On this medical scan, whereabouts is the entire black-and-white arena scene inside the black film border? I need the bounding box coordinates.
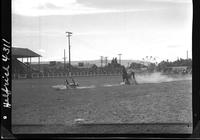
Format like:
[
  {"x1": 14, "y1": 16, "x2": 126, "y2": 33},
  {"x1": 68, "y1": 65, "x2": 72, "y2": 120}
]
[{"x1": 11, "y1": 0, "x2": 193, "y2": 134}]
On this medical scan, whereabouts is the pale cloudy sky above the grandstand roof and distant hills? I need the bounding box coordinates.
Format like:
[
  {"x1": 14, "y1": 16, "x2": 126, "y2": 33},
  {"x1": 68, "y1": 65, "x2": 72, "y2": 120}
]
[{"x1": 12, "y1": 0, "x2": 192, "y2": 61}]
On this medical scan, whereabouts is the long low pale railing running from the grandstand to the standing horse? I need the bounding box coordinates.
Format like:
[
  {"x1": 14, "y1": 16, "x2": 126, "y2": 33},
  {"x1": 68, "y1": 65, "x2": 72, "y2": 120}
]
[{"x1": 12, "y1": 72, "x2": 121, "y2": 79}]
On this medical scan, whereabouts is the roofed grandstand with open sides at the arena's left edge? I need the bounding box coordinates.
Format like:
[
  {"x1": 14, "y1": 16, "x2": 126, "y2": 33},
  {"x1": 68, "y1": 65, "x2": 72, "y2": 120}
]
[{"x1": 12, "y1": 47, "x2": 41, "y2": 78}]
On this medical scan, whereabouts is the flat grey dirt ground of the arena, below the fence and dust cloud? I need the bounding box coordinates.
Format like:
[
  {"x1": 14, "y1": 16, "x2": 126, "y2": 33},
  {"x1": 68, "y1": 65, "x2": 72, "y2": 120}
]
[{"x1": 12, "y1": 76, "x2": 192, "y2": 134}]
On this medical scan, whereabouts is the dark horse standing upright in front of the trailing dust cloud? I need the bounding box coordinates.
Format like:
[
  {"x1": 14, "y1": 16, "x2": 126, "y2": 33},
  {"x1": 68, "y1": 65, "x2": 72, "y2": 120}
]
[{"x1": 122, "y1": 67, "x2": 138, "y2": 85}]
